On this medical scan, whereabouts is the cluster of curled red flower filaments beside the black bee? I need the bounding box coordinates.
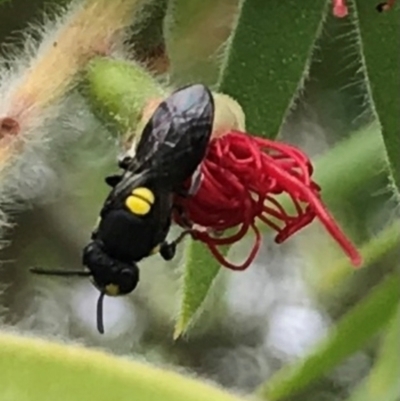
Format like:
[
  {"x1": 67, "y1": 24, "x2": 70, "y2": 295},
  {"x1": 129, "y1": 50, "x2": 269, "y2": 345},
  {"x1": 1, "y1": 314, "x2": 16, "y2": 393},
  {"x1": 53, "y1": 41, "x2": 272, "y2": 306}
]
[{"x1": 175, "y1": 131, "x2": 361, "y2": 270}]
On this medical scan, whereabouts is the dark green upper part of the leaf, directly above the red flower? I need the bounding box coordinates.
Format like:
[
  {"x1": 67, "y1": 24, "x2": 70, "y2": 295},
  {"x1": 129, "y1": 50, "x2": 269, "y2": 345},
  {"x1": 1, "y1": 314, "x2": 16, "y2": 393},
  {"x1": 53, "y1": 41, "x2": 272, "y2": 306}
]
[{"x1": 218, "y1": 0, "x2": 330, "y2": 138}]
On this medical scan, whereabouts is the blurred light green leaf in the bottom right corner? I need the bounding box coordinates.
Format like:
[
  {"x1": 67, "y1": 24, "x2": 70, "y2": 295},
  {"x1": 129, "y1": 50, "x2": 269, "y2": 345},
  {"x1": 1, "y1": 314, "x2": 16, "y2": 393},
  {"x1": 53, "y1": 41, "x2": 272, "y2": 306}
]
[{"x1": 348, "y1": 305, "x2": 400, "y2": 401}]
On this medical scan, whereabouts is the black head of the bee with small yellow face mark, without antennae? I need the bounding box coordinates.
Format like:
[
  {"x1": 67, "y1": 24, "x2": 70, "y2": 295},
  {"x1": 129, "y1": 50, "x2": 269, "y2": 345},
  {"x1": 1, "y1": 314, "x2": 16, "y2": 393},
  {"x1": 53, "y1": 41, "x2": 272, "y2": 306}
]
[{"x1": 82, "y1": 240, "x2": 139, "y2": 296}]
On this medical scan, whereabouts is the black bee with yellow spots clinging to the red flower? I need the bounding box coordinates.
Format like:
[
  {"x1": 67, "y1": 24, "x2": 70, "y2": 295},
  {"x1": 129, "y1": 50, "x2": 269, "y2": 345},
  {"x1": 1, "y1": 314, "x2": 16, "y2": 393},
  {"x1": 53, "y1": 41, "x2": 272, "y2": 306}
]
[{"x1": 31, "y1": 84, "x2": 214, "y2": 333}]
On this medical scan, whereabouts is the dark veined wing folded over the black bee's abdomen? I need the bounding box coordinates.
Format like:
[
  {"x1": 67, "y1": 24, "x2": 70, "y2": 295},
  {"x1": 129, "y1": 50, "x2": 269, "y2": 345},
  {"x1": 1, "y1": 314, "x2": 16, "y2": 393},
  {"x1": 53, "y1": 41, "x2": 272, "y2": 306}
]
[{"x1": 128, "y1": 84, "x2": 214, "y2": 188}]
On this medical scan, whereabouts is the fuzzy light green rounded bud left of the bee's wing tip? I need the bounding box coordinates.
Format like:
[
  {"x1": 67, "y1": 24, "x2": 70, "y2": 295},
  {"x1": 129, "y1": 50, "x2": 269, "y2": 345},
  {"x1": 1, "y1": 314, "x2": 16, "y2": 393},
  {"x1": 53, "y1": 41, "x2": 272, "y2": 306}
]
[{"x1": 84, "y1": 57, "x2": 164, "y2": 132}]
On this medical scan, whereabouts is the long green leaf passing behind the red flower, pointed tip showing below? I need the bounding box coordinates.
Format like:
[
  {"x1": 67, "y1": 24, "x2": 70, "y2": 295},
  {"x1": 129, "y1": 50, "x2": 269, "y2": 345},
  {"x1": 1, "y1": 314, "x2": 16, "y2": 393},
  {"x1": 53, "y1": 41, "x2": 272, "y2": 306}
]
[{"x1": 175, "y1": 0, "x2": 327, "y2": 337}]
